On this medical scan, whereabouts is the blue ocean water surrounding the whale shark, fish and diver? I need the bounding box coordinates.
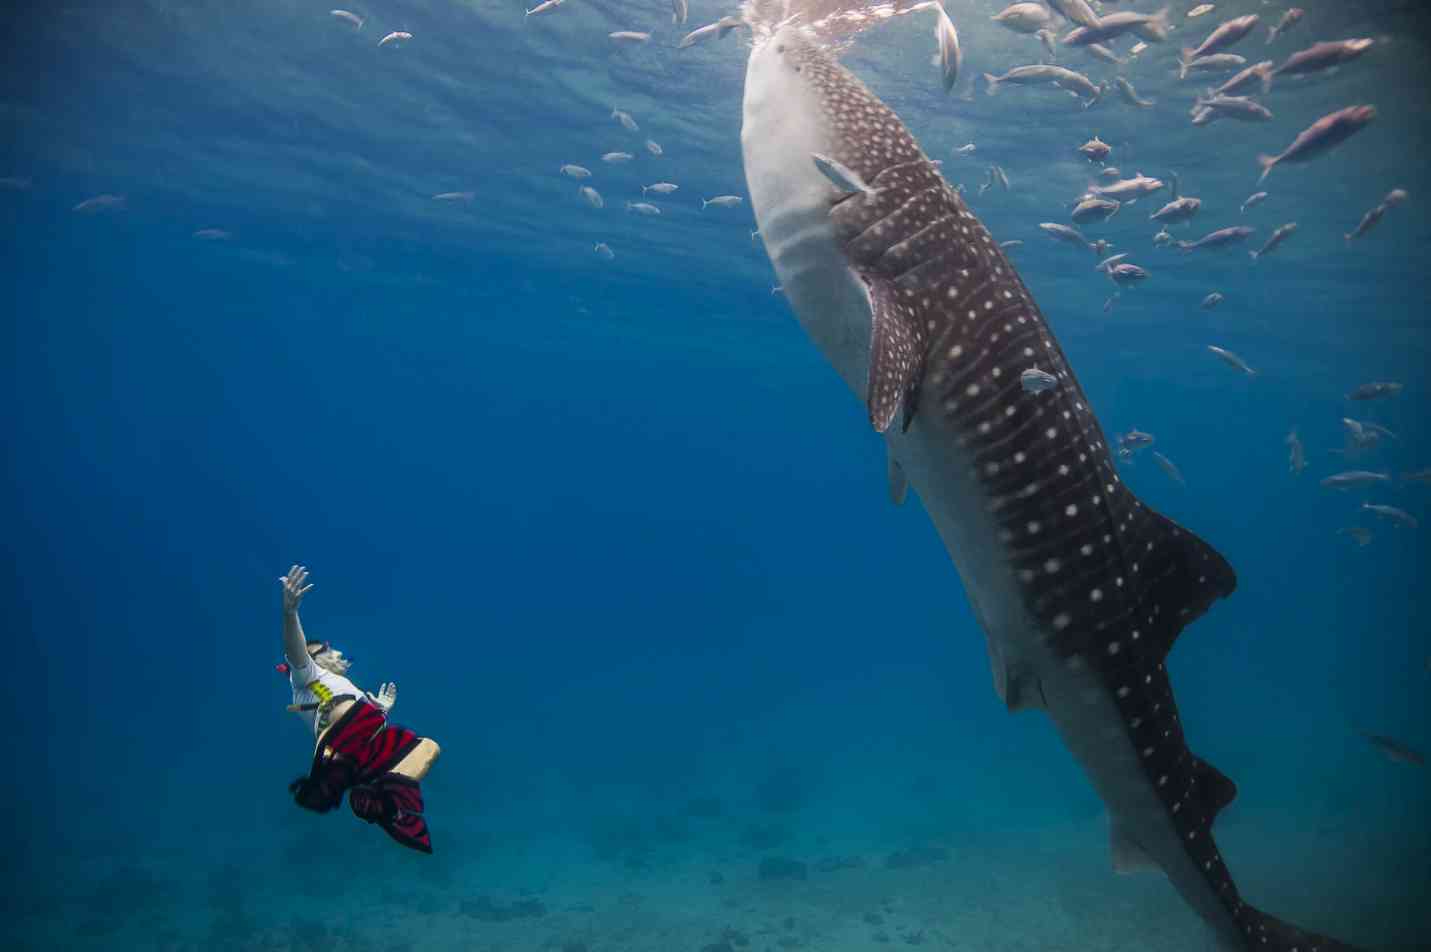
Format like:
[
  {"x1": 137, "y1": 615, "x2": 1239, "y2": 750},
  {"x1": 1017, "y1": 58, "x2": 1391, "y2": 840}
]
[{"x1": 0, "y1": 0, "x2": 1431, "y2": 952}]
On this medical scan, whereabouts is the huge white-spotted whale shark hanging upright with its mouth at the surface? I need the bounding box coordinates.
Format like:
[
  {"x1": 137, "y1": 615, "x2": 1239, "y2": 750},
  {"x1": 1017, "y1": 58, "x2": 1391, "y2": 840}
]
[{"x1": 741, "y1": 9, "x2": 1351, "y2": 952}]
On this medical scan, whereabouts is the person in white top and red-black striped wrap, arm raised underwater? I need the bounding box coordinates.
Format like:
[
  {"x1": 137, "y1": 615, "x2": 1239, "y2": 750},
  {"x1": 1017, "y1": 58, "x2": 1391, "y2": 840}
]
[{"x1": 278, "y1": 565, "x2": 441, "y2": 853}]
